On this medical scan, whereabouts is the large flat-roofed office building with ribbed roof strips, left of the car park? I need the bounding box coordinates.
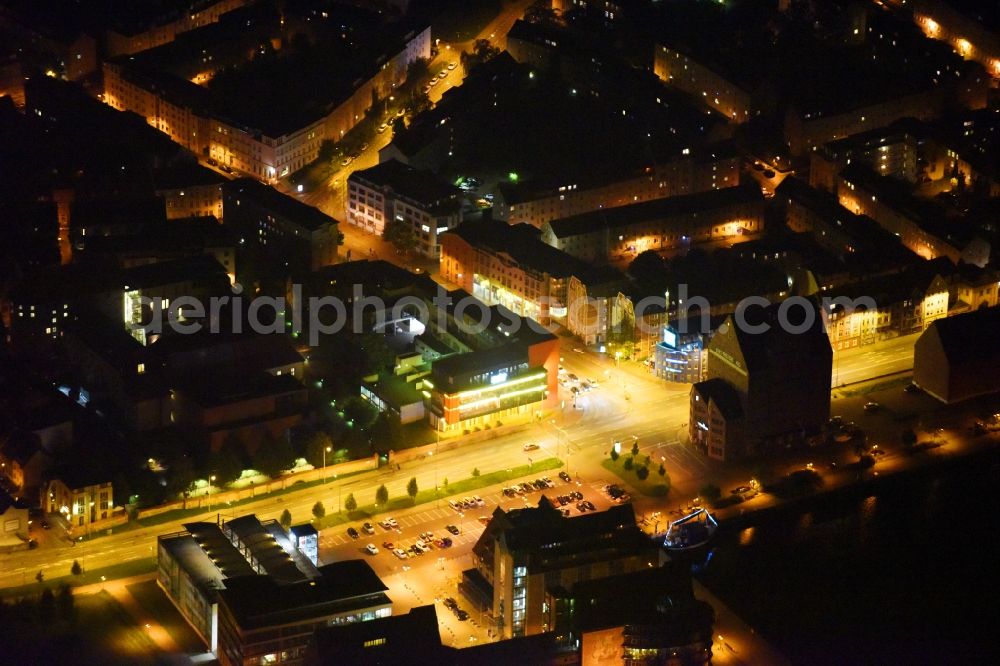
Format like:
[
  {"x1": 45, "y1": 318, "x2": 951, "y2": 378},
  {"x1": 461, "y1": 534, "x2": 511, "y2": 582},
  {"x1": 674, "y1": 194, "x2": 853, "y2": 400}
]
[{"x1": 157, "y1": 508, "x2": 392, "y2": 666}]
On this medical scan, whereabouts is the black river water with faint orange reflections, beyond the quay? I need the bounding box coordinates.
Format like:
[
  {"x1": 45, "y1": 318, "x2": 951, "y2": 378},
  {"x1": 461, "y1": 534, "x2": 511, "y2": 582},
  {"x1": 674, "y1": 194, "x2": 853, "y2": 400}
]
[{"x1": 698, "y1": 451, "x2": 1000, "y2": 666}]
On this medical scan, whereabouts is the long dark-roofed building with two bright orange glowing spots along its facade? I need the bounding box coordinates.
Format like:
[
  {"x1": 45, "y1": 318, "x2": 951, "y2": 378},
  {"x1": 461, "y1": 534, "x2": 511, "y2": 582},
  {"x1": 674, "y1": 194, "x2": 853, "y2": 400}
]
[{"x1": 542, "y1": 186, "x2": 764, "y2": 262}]
